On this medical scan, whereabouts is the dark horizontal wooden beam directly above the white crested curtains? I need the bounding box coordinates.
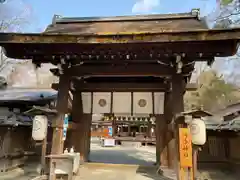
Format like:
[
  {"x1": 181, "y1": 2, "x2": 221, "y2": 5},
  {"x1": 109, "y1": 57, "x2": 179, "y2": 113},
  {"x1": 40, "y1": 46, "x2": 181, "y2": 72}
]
[{"x1": 52, "y1": 82, "x2": 197, "y2": 92}]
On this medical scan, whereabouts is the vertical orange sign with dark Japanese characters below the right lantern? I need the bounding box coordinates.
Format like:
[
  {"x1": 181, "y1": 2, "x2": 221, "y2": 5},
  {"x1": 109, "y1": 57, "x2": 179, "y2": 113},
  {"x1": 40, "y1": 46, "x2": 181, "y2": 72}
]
[{"x1": 179, "y1": 128, "x2": 193, "y2": 167}]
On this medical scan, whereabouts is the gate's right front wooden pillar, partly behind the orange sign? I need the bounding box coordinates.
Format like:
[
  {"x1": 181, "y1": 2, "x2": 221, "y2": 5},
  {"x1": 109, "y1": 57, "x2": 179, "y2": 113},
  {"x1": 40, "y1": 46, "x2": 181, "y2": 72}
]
[{"x1": 172, "y1": 74, "x2": 185, "y2": 180}]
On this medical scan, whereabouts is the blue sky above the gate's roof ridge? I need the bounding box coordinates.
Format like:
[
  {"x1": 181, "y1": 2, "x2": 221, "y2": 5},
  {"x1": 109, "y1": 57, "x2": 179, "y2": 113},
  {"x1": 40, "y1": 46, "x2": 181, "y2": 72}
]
[{"x1": 14, "y1": 0, "x2": 216, "y2": 32}]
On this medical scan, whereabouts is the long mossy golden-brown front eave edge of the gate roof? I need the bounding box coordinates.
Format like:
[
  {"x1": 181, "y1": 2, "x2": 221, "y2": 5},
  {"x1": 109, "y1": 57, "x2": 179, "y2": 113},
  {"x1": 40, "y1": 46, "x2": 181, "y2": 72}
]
[{"x1": 0, "y1": 28, "x2": 240, "y2": 45}]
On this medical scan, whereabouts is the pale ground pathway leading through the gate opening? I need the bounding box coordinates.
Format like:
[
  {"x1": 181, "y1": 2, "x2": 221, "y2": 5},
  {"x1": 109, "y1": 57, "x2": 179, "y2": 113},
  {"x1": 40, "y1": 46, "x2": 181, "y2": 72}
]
[{"x1": 76, "y1": 138, "x2": 176, "y2": 180}]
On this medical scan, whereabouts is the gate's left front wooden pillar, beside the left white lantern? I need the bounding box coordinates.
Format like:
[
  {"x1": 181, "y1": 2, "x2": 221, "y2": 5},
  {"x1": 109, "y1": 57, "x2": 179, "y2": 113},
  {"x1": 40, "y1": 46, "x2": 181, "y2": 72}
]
[{"x1": 51, "y1": 75, "x2": 70, "y2": 154}]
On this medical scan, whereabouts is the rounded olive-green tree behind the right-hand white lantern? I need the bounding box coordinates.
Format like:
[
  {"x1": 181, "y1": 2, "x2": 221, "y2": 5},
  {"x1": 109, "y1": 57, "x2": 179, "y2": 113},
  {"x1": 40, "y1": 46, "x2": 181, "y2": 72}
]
[{"x1": 185, "y1": 70, "x2": 240, "y2": 111}]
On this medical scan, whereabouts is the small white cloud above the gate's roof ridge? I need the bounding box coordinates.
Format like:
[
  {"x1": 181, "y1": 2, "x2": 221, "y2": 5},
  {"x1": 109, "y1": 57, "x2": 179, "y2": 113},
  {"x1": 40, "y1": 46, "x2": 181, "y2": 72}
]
[{"x1": 132, "y1": 0, "x2": 159, "y2": 13}]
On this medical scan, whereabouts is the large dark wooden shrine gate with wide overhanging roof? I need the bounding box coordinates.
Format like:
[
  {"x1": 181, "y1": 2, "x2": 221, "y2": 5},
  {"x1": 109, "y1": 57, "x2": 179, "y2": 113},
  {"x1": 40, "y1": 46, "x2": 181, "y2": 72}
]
[{"x1": 0, "y1": 10, "x2": 240, "y2": 180}]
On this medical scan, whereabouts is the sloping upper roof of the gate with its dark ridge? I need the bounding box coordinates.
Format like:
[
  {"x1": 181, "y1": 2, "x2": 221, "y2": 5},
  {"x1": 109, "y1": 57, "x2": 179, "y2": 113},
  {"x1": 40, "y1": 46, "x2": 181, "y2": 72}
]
[{"x1": 44, "y1": 11, "x2": 207, "y2": 35}]
